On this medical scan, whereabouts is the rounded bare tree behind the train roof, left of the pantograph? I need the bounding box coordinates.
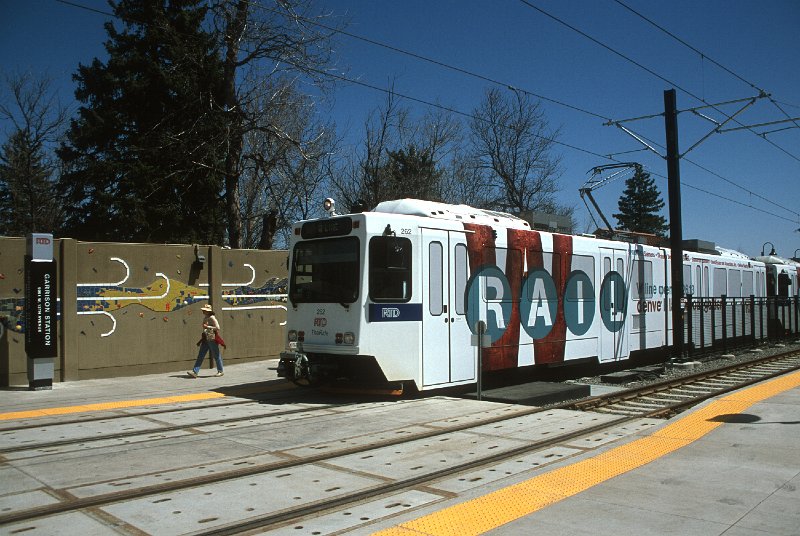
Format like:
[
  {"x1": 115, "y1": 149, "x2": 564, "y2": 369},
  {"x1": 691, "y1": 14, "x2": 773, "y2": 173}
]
[{"x1": 470, "y1": 88, "x2": 561, "y2": 213}]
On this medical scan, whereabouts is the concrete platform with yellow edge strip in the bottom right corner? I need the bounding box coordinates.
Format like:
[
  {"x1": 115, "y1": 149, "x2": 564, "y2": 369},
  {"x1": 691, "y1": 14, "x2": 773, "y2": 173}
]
[{"x1": 374, "y1": 372, "x2": 800, "y2": 536}]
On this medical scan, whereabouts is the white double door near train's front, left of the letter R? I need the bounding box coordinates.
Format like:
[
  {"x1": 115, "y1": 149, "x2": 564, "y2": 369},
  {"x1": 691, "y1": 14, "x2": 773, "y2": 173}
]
[{"x1": 422, "y1": 229, "x2": 475, "y2": 387}]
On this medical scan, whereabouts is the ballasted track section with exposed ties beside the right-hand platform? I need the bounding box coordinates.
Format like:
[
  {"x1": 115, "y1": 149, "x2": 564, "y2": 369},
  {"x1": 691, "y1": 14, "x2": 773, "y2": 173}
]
[{"x1": 557, "y1": 350, "x2": 800, "y2": 418}]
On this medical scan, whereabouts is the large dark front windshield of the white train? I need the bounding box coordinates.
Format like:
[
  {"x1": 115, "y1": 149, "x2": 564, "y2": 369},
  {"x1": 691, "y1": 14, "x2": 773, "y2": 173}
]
[{"x1": 289, "y1": 237, "x2": 360, "y2": 304}]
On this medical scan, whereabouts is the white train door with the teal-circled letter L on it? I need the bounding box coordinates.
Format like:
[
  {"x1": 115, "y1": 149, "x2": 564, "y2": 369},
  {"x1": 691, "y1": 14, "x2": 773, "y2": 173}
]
[{"x1": 599, "y1": 248, "x2": 630, "y2": 361}]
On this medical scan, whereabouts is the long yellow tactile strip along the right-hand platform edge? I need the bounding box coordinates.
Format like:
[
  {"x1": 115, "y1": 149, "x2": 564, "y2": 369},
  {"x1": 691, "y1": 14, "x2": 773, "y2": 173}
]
[{"x1": 373, "y1": 372, "x2": 800, "y2": 536}]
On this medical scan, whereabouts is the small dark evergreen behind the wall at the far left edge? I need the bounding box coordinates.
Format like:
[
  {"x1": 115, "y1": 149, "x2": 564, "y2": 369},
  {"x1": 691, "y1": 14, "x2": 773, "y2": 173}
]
[{"x1": 0, "y1": 130, "x2": 59, "y2": 236}]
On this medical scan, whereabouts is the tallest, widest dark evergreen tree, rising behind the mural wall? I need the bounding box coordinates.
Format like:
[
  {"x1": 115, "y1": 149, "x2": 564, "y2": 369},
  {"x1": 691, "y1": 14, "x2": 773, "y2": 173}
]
[{"x1": 59, "y1": 0, "x2": 225, "y2": 244}]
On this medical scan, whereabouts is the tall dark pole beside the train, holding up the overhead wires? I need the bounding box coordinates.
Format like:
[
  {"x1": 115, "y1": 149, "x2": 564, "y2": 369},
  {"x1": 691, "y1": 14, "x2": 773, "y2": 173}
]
[{"x1": 664, "y1": 89, "x2": 684, "y2": 358}]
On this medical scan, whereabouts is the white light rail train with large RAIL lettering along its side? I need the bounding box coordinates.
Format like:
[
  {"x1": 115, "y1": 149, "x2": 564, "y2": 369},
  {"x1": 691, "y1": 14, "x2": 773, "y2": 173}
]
[{"x1": 279, "y1": 199, "x2": 767, "y2": 390}]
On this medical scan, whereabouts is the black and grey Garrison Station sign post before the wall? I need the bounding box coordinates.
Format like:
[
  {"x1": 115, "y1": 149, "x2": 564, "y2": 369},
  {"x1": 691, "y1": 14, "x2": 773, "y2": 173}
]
[{"x1": 25, "y1": 233, "x2": 58, "y2": 391}]
